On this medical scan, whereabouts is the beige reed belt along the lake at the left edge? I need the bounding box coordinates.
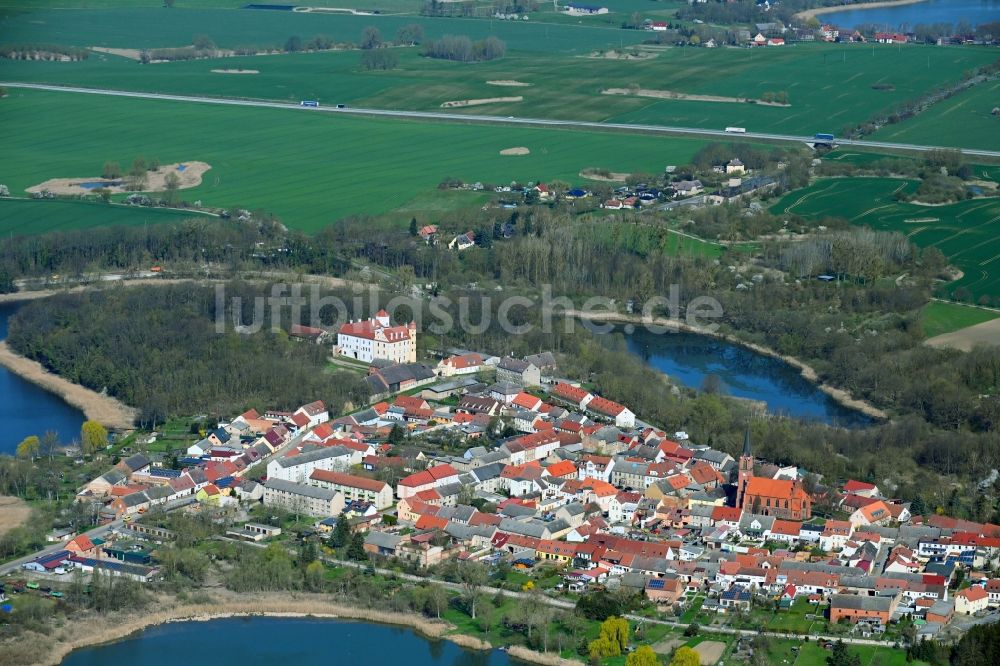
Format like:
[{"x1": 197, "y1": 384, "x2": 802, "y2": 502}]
[{"x1": 0, "y1": 340, "x2": 138, "y2": 431}]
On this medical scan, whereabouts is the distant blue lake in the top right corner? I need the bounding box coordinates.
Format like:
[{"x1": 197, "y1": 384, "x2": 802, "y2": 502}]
[{"x1": 817, "y1": 0, "x2": 1000, "y2": 30}]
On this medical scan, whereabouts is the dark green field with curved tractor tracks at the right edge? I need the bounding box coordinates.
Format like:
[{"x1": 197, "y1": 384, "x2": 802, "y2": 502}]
[{"x1": 771, "y1": 178, "x2": 1000, "y2": 302}]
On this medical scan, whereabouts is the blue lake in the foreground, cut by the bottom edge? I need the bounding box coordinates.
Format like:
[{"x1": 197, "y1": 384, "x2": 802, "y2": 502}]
[{"x1": 63, "y1": 617, "x2": 525, "y2": 666}]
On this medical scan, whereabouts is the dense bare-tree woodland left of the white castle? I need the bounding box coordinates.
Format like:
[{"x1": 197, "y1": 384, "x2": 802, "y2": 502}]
[{"x1": 8, "y1": 283, "x2": 366, "y2": 428}]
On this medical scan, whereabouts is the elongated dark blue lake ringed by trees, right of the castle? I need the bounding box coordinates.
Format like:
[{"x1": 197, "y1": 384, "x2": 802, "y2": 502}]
[{"x1": 625, "y1": 327, "x2": 872, "y2": 428}]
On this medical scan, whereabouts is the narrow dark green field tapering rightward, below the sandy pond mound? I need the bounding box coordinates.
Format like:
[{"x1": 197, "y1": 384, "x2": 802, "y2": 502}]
[{"x1": 0, "y1": 199, "x2": 211, "y2": 238}]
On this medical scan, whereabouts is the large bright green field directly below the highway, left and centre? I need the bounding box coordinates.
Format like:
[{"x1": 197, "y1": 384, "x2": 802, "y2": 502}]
[{"x1": 0, "y1": 91, "x2": 704, "y2": 231}]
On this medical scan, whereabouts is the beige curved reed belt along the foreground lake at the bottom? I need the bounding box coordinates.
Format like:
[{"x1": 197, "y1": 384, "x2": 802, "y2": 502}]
[{"x1": 47, "y1": 595, "x2": 560, "y2": 666}]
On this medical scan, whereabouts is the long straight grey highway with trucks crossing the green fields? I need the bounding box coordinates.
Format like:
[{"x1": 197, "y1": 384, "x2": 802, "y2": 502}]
[{"x1": 0, "y1": 82, "x2": 1000, "y2": 158}]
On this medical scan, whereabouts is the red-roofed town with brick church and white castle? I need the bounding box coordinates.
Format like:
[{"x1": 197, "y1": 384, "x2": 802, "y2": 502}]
[{"x1": 7, "y1": 311, "x2": 1000, "y2": 642}]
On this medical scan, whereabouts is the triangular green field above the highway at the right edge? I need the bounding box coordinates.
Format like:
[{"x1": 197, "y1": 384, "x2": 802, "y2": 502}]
[{"x1": 872, "y1": 81, "x2": 1000, "y2": 150}]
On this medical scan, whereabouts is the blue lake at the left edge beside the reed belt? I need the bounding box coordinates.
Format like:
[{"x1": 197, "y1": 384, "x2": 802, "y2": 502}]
[{"x1": 0, "y1": 303, "x2": 85, "y2": 455}]
